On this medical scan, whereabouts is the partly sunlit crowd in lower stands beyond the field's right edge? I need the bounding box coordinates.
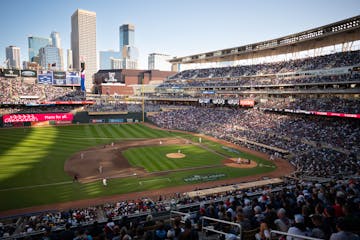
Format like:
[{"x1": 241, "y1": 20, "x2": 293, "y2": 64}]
[{"x1": 150, "y1": 107, "x2": 360, "y2": 176}]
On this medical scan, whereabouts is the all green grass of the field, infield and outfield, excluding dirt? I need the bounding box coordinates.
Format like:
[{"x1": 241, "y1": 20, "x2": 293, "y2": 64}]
[{"x1": 0, "y1": 124, "x2": 274, "y2": 211}]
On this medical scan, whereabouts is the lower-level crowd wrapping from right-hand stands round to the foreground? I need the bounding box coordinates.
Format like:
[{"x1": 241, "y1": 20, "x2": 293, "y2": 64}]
[{"x1": 0, "y1": 107, "x2": 360, "y2": 239}]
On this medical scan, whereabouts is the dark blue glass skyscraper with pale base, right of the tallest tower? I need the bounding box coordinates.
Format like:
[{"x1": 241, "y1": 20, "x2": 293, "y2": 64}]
[{"x1": 120, "y1": 24, "x2": 139, "y2": 69}]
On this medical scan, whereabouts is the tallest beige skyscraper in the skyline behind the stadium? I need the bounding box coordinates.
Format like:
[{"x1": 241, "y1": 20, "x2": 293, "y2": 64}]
[{"x1": 71, "y1": 9, "x2": 97, "y2": 91}]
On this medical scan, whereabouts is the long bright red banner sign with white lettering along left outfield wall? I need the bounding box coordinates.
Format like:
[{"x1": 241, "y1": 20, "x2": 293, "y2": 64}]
[{"x1": 3, "y1": 113, "x2": 74, "y2": 123}]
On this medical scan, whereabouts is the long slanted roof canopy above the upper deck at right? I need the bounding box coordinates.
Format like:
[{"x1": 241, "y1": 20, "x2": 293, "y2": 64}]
[{"x1": 170, "y1": 15, "x2": 360, "y2": 64}]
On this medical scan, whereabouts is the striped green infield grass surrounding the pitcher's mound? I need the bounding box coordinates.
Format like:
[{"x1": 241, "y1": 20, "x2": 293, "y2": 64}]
[{"x1": 122, "y1": 145, "x2": 224, "y2": 172}]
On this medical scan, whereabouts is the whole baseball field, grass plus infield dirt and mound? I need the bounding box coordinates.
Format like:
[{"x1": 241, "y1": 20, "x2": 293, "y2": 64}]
[{"x1": 0, "y1": 124, "x2": 276, "y2": 212}]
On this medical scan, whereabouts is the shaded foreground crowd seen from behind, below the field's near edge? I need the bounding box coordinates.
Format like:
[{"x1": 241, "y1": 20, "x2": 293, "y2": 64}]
[{"x1": 0, "y1": 176, "x2": 360, "y2": 240}]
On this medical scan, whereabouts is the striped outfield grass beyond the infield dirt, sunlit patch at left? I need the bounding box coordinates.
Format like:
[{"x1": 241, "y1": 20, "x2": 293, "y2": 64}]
[{"x1": 0, "y1": 124, "x2": 169, "y2": 189}]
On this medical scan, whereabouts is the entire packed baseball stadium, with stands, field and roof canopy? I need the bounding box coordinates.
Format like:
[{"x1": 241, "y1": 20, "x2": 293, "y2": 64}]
[{"x1": 0, "y1": 16, "x2": 360, "y2": 239}]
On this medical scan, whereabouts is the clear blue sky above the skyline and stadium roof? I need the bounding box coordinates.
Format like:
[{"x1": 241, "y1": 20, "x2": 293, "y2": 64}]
[{"x1": 0, "y1": 0, "x2": 360, "y2": 68}]
